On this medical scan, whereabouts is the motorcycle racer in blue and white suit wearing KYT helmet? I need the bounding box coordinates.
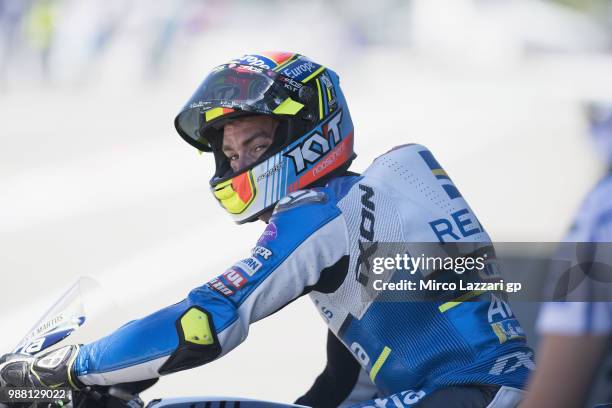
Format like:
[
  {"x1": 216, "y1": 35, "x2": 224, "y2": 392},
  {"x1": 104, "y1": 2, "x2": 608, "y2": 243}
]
[{"x1": 0, "y1": 52, "x2": 534, "y2": 408}]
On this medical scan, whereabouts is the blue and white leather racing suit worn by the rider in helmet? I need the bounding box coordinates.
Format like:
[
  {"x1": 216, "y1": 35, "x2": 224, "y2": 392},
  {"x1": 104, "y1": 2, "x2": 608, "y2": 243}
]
[{"x1": 74, "y1": 145, "x2": 534, "y2": 406}]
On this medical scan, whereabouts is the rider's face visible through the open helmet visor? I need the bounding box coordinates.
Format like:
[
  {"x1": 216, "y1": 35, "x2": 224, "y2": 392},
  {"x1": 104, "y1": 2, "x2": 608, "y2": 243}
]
[{"x1": 221, "y1": 116, "x2": 278, "y2": 172}]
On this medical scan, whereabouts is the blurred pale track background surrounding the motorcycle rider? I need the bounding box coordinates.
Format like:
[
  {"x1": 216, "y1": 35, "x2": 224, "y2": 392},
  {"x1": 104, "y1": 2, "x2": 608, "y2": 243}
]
[{"x1": 0, "y1": 0, "x2": 612, "y2": 401}]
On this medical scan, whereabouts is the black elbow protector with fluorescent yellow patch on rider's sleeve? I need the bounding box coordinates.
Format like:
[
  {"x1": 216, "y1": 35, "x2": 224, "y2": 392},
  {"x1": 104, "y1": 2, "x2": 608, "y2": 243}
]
[{"x1": 158, "y1": 306, "x2": 221, "y2": 375}]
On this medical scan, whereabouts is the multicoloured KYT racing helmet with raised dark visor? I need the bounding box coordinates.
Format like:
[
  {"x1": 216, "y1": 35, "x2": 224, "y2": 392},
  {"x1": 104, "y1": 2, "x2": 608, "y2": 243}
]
[{"x1": 174, "y1": 52, "x2": 356, "y2": 224}]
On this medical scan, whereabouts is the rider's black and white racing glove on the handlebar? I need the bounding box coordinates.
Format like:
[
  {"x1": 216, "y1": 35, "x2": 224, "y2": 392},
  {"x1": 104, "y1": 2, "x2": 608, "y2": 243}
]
[{"x1": 0, "y1": 345, "x2": 84, "y2": 390}]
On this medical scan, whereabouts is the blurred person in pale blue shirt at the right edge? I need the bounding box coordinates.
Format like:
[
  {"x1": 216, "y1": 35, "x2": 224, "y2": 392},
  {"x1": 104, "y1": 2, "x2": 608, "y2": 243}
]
[{"x1": 521, "y1": 103, "x2": 612, "y2": 408}]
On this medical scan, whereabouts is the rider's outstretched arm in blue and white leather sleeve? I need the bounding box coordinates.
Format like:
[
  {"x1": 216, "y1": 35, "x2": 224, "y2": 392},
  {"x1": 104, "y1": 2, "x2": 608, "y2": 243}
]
[{"x1": 74, "y1": 190, "x2": 348, "y2": 385}]
